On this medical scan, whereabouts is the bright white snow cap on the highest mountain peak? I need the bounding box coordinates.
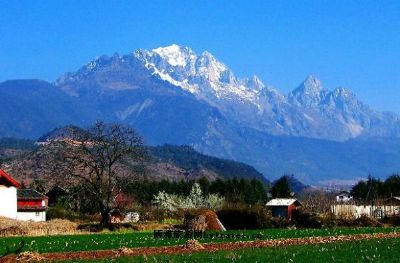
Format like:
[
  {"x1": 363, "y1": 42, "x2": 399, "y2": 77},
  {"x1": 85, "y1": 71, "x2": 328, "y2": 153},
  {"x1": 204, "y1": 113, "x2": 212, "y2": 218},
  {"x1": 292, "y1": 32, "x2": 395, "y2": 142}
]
[{"x1": 134, "y1": 44, "x2": 264, "y2": 102}]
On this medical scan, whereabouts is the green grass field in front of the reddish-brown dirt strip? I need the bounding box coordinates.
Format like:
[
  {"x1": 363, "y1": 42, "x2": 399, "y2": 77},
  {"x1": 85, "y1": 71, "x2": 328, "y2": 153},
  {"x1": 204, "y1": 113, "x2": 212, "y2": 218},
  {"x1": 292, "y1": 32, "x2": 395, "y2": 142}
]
[{"x1": 72, "y1": 239, "x2": 400, "y2": 263}]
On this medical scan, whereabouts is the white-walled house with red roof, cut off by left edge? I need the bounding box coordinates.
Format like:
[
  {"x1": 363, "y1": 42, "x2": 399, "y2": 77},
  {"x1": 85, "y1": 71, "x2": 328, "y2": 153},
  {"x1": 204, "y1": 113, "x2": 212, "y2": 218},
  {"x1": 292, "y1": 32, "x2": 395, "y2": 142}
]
[{"x1": 0, "y1": 169, "x2": 20, "y2": 219}]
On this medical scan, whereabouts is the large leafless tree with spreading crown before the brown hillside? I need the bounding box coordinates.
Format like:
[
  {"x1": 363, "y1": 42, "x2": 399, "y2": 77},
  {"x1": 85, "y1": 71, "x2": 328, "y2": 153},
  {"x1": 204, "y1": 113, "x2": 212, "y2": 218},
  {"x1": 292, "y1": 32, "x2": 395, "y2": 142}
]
[{"x1": 42, "y1": 122, "x2": 147, "y2": 227}]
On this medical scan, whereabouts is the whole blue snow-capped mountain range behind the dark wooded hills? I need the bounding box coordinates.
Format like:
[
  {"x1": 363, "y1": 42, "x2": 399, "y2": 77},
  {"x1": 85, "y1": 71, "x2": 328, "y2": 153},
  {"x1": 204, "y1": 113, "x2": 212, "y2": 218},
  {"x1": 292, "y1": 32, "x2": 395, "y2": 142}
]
[{"x1": 0, "y1": 45, "x2": 400, "y2": 184}]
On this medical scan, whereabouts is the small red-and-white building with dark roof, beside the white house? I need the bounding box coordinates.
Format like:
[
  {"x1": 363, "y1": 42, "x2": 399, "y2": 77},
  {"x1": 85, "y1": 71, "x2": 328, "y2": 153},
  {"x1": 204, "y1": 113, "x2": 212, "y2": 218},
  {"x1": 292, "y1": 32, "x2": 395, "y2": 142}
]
[{"x1": 17, "y1": 189, "x2": 48, "y2": 222}]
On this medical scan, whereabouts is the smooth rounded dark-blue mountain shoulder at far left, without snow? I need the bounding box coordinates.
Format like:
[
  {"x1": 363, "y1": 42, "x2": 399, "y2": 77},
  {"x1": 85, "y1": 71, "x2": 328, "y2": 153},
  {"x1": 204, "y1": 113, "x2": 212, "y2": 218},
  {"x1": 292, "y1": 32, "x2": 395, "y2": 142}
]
[{"x1": 0, "y1": 80, "x2": 86, "y2": 138}]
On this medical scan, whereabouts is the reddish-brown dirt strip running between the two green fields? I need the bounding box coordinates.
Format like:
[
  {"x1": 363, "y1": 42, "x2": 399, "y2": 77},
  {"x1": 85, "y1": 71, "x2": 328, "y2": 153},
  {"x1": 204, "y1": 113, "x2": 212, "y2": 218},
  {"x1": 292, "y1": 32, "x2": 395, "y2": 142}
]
[{"x1": 0, "y1": 233, "x2": 400, "y2": 262}]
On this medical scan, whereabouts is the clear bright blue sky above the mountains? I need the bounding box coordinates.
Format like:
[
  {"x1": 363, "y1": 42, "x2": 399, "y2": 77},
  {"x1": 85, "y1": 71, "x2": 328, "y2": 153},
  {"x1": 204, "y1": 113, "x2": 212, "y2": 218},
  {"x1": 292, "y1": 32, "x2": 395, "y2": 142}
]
[{"x1": 0, "y1": 0, "x2": 400, "y2": 112}]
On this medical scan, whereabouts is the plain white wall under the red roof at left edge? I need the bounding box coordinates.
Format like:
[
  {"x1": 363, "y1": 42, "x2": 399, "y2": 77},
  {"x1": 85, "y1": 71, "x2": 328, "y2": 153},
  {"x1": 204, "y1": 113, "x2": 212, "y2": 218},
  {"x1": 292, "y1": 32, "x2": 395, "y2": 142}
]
[{"x1": 0, "y1": 185, "x2": 17, "y2": 219}]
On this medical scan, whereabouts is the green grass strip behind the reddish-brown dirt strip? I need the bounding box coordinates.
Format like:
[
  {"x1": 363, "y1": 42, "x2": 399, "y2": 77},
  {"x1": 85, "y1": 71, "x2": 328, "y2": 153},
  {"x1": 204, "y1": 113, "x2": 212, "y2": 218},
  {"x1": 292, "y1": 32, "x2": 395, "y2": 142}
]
[{"x1": 0, "y1": 228, "x2": 400, "y2": 255}]
